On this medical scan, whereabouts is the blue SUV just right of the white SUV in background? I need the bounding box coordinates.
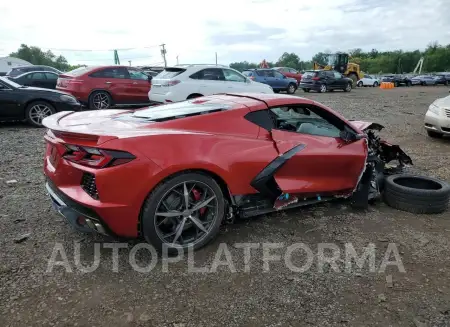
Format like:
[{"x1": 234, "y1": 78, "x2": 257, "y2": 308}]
[{"x1": 242, "y1": 69, "x2": 298, "y2": 94}]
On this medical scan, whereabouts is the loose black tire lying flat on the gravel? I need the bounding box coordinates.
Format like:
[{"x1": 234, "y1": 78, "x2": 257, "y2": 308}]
[{"x1": 383, "y1": 174, "x2": 450, "y2": 214}]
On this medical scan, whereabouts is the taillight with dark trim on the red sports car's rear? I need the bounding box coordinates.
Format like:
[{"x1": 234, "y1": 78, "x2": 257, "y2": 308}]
[{"x1": 63, "y1": 144, "x2": 136, "y2": 168}]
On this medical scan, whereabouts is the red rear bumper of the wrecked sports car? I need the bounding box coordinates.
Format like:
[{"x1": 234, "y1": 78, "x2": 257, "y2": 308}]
[{"x1": 44, "y1": 140, "x2": 160, "y2": 238}]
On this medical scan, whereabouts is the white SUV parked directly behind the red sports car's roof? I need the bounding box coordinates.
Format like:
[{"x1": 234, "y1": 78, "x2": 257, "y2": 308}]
[{"x1": 148, "y1": 65, "x2": 273, "y2": 103}]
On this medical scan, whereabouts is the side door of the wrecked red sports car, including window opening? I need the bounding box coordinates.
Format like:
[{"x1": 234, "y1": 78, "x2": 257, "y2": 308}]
[{"x1": 270, "y1": 105, "x2": 367, "y2": 196}]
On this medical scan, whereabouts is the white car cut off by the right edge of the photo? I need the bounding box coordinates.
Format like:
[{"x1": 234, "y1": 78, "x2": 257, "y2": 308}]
[{"x1": 424, "y1": 91, "x2": 450, "y2": 138}]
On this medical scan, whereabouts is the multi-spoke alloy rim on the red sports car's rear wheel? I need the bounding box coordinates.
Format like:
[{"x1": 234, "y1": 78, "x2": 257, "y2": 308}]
[{"x1": 154, "y1": 181, "x2": 219, "y2": 248}]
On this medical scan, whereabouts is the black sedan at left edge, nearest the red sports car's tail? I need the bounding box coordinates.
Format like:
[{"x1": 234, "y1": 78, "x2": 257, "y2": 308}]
[{"x1": 0, "y1": 77, "x2": 81, "y2": 127}]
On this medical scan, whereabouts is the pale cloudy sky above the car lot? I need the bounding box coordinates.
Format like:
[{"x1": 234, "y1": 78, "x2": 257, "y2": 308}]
[{"x1": 0, "y1": 0, "x2": 450, "y2": 65}]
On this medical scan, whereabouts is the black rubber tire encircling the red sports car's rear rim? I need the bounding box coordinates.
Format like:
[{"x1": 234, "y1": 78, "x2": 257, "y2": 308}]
[{"x1": 141, "y1": 172, "x2": 226, "y2": 254}]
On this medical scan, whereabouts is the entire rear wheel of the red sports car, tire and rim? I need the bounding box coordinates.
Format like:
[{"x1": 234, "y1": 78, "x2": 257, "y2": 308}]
[{"x1": 141, "y1": 173, "x2": 225, "y2": 253}]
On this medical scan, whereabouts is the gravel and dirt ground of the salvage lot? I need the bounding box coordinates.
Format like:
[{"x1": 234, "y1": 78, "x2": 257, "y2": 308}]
[{"x1": 0, "y1": 87, "x2": 450, "y2": 327}]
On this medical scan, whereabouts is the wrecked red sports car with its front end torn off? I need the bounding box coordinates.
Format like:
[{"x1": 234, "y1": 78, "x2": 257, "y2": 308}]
[{"x1": 43, "y1": 94, "x2": 412, "y2": 250}]
